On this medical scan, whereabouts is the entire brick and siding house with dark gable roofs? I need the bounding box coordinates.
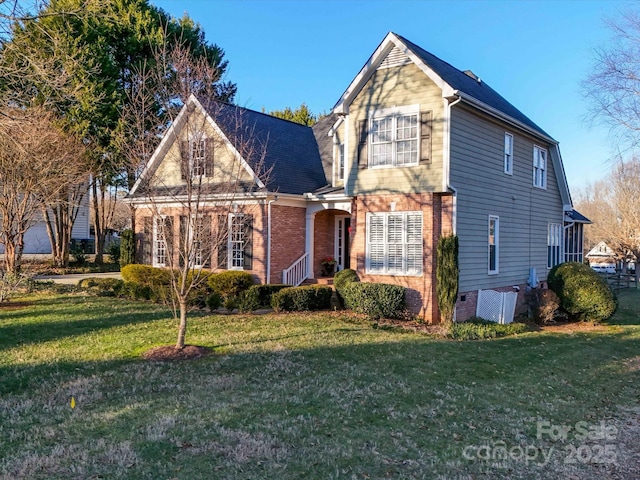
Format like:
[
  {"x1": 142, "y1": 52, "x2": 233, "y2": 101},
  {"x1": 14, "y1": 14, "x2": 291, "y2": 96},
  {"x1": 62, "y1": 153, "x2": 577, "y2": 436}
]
[{"x1": 129, "y1": 33, "x2": 589, "y2": 322}]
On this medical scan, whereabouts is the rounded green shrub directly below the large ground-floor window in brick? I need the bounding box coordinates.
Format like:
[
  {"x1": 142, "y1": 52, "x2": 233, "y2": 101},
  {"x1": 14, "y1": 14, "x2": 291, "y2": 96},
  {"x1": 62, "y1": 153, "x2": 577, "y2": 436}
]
[{"x1": 342, "y1": 282, "x2": 405, "y2": 319}]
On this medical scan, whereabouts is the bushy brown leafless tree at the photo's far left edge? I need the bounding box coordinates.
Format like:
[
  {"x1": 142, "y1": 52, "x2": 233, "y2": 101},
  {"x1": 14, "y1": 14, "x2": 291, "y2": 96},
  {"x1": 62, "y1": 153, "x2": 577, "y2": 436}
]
[{"x1": 0, "y1": 108, "x2": 82, "y2": 272}]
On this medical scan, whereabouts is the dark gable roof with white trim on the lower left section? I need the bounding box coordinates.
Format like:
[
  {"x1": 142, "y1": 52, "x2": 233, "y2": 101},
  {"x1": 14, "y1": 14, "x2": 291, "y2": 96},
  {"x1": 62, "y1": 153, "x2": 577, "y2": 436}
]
[{"x1": 129, "y1": 95, "x2": 327, "y2": 197}]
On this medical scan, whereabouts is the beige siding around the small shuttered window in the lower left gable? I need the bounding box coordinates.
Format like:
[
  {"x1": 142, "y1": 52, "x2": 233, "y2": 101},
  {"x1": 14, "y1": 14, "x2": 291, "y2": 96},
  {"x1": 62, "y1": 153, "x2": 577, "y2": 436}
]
[{"x1": 152, "y1": 110, "x2": 252, "y2": 187}]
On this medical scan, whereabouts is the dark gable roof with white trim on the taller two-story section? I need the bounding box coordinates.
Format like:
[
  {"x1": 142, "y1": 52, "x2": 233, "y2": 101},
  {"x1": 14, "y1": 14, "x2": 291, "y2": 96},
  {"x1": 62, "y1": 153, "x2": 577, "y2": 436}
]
[{"x1": 333, "y1": 32, "x2": 557, "y2": 143}]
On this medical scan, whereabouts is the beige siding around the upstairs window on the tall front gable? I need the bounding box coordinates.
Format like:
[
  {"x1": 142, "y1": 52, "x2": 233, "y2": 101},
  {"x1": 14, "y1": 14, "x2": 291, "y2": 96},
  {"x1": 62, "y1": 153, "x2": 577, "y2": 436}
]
[{"x1": 348, "y1": 63, "x2": 443, "y2": 195}]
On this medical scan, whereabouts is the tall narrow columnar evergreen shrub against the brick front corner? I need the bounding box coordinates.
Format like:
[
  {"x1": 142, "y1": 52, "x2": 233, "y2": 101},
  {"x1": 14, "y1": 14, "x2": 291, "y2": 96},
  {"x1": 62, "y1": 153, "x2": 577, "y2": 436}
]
[{"x1": 436, "y1": 235, "x2": 459, "y2": 323}]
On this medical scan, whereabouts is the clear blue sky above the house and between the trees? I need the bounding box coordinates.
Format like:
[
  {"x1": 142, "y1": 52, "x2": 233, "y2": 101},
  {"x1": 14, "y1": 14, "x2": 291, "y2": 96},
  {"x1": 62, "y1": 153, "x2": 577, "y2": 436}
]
[{"x1": 152, "y1": 0, "x2": 629, "y2": 190}]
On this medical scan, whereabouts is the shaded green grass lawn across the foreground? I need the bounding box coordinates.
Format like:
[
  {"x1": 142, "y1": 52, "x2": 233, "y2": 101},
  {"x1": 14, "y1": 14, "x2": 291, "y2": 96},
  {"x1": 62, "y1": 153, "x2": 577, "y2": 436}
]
[{"x1": 0, "y1": 290, "x2": 640, "y2": 480}]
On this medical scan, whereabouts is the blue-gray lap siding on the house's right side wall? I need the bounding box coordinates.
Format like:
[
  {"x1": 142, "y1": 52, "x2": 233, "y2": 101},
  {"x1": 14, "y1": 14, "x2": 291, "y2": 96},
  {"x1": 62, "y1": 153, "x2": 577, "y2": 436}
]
[{"x1": 451, "y1": 107, "x2": 563, "y2": 292}]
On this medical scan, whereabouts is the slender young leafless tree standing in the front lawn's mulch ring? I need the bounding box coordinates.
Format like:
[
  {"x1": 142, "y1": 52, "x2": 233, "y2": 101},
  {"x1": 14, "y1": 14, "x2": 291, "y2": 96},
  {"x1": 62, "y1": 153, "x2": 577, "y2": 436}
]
[{"x1": 124, "y1": 36, "x2": 266, "y2": 349}]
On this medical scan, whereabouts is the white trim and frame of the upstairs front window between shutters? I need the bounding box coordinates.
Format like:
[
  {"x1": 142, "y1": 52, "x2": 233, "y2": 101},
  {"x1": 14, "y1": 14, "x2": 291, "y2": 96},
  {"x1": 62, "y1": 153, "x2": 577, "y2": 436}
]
[{"x1": 367, "y1": 104, "x2": 422, "y2": 169}]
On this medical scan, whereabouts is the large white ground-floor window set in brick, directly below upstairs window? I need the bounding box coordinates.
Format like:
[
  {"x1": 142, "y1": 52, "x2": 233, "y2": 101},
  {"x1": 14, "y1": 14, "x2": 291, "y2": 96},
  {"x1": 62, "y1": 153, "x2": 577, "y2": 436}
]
[{"x1": 367, "y1": 212, "x2": 422, "y2": 275}]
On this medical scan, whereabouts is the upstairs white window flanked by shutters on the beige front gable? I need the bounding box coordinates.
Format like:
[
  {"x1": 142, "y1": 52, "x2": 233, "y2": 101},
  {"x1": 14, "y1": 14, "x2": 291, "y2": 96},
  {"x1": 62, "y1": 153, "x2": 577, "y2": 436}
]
[{"x1": 369, "y1": 106, "x2": 420, "y2": 167}]
